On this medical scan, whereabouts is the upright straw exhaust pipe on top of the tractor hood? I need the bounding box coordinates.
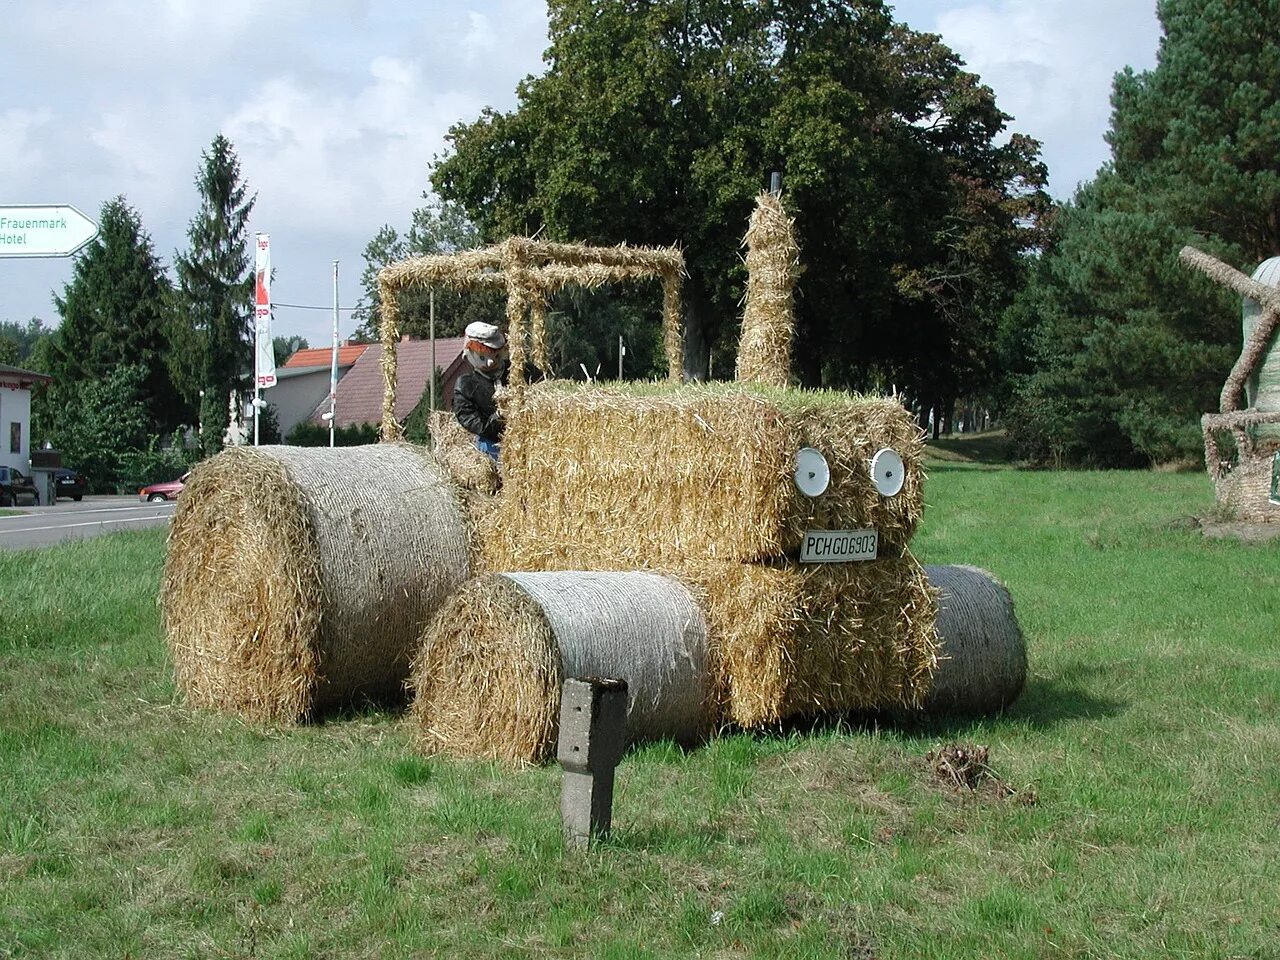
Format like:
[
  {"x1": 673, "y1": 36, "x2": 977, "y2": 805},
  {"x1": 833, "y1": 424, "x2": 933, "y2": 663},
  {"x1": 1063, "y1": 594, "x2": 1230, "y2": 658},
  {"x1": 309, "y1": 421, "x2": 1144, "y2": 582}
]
[{"x1": 737, "y1": 192, "x2": 800, "y2": 387}]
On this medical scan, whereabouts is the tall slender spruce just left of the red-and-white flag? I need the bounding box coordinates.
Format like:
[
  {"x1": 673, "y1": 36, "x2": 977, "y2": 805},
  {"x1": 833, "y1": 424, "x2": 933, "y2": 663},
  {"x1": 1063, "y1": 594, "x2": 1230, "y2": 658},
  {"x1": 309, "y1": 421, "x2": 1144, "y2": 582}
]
[{"x1": 172, "y1": 133, "x2": 256, "y2": 449}]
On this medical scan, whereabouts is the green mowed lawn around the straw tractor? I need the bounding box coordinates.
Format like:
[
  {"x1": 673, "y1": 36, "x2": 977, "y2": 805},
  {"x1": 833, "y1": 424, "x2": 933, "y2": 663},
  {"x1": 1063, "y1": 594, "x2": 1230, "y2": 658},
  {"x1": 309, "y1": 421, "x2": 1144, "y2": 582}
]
[{"x1": 0, "y1": 463, "x2": 1280, "y2": 960}]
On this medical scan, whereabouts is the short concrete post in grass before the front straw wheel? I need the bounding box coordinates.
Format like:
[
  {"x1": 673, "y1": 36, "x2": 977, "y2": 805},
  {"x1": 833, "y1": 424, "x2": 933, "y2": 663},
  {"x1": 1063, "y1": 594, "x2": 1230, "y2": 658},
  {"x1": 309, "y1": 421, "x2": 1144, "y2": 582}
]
[{"x1": 557, "y1": 677, "x2": 627, "y2": 847}]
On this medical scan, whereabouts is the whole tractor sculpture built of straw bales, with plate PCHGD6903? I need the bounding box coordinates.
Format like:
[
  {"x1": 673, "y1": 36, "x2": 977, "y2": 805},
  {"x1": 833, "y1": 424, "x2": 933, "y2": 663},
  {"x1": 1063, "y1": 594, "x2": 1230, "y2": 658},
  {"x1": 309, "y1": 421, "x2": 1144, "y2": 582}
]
[{"x1": 163, "y1": 195, "x2": 1027, "y2": 762}]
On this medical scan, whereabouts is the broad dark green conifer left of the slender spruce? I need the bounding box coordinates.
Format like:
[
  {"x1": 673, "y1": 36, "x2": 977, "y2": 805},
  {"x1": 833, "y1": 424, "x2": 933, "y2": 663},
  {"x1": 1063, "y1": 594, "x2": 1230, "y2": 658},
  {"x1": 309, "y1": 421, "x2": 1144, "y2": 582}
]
[{"x1": 47, "y1": 196, "x2": 180, "y2": 433}]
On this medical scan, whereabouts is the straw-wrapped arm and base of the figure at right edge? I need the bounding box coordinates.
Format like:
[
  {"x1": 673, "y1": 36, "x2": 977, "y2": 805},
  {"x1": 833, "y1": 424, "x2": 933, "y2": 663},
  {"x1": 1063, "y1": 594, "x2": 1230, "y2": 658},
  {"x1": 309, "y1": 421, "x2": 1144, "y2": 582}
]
[{"x1": 1179, "y1": 247, "x2": 1280, "y2": 522}]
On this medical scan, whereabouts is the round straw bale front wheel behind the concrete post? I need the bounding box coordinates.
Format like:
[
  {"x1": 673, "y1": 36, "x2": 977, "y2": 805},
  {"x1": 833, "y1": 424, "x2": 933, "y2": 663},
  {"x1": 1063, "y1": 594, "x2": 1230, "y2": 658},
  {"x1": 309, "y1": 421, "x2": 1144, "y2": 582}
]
[{"x1": 410, "y1": 571, "x2": 710, "y2": 763}]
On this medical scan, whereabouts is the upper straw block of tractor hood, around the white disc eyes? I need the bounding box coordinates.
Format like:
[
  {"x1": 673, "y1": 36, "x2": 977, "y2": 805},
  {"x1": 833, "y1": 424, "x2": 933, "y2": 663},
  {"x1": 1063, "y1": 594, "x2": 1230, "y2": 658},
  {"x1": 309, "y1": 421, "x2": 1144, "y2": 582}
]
[{"x1": 484, "y1": 381, "x2": 924, "y2": 570}]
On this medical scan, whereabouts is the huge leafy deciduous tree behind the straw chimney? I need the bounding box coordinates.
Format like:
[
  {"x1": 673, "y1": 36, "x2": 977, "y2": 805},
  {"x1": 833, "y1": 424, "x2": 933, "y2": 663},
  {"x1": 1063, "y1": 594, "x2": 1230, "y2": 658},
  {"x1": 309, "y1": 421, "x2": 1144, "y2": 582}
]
[{"x1": 433, "y1": 0, "x2": 1046, "y2": 403}]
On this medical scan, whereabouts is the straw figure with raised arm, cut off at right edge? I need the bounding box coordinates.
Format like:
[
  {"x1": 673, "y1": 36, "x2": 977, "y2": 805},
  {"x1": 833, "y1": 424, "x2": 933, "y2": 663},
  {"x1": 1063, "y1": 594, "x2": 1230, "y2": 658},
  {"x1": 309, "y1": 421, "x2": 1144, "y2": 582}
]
[{"x1": 1179, "y1": 247, "x2": 1280, "y2": 522}]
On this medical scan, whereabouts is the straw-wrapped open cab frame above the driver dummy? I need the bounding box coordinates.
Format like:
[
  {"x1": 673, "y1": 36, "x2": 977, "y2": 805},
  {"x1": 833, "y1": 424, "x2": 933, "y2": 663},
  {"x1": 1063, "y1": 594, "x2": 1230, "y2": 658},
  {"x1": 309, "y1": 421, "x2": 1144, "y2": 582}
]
[{"x1": 378, "y1": 237, "x2": 685, "y2": 440}]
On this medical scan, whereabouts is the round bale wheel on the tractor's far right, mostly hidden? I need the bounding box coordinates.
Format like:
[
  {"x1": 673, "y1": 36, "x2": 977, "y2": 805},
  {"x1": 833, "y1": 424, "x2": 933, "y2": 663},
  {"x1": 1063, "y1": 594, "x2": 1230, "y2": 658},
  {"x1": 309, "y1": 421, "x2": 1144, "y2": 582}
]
[{"x1": 923, "y1": 566, "x2": 1027, "y2": 714}]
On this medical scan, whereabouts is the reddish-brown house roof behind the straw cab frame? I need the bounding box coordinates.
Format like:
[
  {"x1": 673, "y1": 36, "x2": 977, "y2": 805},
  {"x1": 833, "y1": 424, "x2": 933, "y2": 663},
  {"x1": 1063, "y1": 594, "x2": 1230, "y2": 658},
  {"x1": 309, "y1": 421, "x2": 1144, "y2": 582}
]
[{"x1": 311, "y1": 337, "x2": 466, "y2": 426}]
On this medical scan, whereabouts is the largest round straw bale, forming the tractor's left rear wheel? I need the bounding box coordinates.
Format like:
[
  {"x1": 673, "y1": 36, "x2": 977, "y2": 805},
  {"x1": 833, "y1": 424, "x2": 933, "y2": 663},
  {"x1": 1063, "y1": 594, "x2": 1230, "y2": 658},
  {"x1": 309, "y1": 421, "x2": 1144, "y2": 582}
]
[{"x1": 160, "y1": 444, "x2": 468, "y2": 722}]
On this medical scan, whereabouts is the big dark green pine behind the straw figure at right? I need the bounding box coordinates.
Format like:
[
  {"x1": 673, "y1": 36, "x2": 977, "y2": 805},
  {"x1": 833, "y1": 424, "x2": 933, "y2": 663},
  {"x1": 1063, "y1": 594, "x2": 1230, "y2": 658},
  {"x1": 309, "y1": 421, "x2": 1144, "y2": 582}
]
[{"x1": 1002, "y1": 0, "x2": 1280, "y2": 465}]
